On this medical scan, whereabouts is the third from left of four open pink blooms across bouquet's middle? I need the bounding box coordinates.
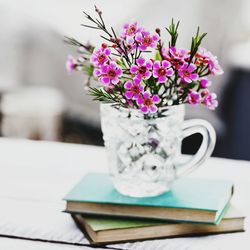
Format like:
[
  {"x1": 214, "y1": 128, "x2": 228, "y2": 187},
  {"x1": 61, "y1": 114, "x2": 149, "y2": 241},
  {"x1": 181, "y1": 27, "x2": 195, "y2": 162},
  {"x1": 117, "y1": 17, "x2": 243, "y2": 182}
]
[{"x1": 153, "y1": 60, "x2": 174, "y2": 83}]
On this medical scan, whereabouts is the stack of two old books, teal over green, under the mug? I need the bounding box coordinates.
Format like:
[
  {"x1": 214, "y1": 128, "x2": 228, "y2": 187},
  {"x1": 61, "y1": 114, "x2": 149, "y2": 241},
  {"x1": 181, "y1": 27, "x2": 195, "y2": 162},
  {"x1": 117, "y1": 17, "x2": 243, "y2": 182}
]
[{"x1": 65, "y1": 173, "x2": 244, "y2": 244}]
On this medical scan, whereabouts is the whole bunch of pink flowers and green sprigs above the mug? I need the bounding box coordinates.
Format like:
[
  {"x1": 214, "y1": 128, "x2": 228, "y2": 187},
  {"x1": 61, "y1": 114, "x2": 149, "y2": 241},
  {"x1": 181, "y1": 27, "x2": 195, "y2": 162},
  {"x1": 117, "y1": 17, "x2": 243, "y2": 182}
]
[{"x1": 66, "y1": 11, "x2": 223, "y2": 113}]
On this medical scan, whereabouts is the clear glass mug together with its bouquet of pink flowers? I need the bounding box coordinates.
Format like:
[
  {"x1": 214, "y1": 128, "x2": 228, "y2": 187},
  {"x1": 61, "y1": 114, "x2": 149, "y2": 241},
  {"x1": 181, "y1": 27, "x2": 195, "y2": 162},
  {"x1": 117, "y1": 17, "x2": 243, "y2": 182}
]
[{"x1": 66, "y1": 8, "x2": 223, "y2": 197}]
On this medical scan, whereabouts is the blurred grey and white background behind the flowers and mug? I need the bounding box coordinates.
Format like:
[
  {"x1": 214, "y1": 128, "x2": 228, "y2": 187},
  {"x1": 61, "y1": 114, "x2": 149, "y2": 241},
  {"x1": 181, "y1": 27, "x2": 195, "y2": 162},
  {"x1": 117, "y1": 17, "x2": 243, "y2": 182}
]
[{"x1": 0, "y1": 0, "x2": 250, "y2": 160}]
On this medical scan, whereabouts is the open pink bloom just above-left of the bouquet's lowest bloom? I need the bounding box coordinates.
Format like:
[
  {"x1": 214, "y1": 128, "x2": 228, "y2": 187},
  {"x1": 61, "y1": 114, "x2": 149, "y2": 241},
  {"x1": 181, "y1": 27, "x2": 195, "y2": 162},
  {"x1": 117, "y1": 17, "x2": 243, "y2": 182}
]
[{"x1": 124, "y1": 78, "x2": 144, "y2": 100}]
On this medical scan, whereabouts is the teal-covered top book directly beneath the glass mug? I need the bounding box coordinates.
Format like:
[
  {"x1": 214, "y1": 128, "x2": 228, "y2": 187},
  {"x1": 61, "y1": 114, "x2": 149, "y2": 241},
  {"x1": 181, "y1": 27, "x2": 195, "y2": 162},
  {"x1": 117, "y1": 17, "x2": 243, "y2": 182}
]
[{"x1": 64, "y1": 173, "x2": 233, "y2": 224}]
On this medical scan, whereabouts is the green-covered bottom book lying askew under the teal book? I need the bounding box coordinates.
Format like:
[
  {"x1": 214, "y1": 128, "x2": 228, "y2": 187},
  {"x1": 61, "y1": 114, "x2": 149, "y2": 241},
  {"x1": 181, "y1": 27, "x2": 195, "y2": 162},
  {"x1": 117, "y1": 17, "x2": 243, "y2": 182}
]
[{"x1": 72, "y1": 205, "x2": 245, "y2": 244}]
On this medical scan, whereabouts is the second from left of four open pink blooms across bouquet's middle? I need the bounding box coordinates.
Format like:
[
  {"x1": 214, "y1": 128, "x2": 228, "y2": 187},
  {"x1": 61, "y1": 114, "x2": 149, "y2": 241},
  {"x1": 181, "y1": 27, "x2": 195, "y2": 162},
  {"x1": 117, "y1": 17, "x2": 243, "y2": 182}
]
[{"x1": 130, "y1": 57, "x2": 153, "y2": 79}]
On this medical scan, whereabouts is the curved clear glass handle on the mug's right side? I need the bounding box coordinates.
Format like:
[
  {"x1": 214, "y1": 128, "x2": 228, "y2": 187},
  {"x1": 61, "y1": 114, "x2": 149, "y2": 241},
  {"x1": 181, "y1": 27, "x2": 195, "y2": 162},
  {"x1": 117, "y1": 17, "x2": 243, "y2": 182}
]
[{"x1": 177, "y1": 119, "x2": 216, "y2": 178}]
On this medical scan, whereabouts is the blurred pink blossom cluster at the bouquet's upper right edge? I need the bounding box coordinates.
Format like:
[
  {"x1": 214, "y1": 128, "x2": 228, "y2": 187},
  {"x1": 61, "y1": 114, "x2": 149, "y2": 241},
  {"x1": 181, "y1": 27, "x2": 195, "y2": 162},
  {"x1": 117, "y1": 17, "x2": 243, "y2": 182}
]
[{"x1": 195, "y1": 47, "x2": 224, "y2": 75}]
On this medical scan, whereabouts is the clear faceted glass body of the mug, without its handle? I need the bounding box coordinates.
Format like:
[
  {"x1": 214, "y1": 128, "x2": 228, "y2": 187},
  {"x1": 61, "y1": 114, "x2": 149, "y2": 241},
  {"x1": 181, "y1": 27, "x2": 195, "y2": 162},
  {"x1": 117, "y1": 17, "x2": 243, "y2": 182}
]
[{"x1": 101, "y1": 104, "x2": 216, "y2": 197}]
